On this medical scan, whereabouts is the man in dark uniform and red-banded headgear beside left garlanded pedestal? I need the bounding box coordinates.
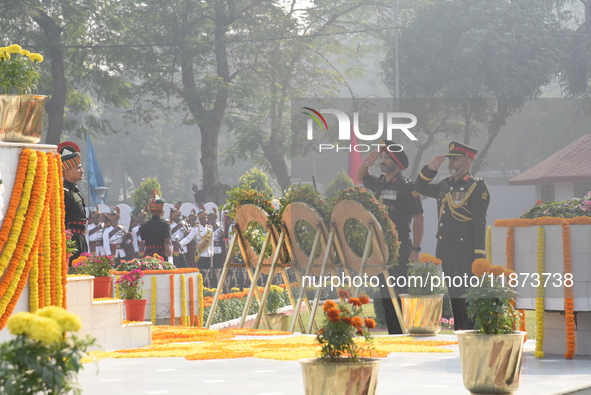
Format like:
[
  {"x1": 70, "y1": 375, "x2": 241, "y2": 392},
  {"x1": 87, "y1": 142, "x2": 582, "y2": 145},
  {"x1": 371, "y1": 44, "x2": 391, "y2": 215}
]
[{"x1": 57, "y1": 141, "x2": 88, "y2": 265}]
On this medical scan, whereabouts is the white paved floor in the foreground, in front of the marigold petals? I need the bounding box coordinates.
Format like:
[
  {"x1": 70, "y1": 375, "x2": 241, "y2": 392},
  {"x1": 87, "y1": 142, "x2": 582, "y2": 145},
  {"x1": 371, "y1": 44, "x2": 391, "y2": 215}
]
[{"x1": 79, "y1": 335, "x2": 591, "y2": 395}]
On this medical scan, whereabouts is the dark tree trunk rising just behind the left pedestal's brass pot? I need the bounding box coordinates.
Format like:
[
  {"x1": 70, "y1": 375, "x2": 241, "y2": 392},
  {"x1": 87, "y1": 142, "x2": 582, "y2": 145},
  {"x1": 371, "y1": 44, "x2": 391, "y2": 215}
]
[{"x1": 32, "y1": 11, "x2": 67, "y2": 144}]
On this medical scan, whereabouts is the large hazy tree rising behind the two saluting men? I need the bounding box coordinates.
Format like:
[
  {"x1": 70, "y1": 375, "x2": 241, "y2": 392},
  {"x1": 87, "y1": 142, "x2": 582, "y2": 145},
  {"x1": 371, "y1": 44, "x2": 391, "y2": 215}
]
[{"x1": 384, "y1": 0, "x2": 561, "y2": 172}]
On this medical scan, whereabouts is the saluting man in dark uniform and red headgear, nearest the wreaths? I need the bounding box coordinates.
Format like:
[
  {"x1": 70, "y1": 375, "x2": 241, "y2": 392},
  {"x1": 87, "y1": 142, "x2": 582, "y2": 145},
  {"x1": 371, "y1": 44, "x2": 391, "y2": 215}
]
[{"x1": 357, "y1": 140, "x2": 424, "y2": 334}]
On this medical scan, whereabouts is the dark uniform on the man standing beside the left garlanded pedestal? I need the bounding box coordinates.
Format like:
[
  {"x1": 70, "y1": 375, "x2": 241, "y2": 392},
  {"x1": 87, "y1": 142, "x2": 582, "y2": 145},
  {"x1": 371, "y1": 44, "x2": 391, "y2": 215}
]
[{"x1": 64, "y1": 180, "x2": 88, "y2": 262}]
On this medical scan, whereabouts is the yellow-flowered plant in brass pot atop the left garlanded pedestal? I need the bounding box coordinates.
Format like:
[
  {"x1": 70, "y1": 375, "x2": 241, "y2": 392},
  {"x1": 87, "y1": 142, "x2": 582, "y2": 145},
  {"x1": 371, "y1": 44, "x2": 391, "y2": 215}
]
[{"x1": 0, "y1": 44, "x2": 47, "y2": 144}]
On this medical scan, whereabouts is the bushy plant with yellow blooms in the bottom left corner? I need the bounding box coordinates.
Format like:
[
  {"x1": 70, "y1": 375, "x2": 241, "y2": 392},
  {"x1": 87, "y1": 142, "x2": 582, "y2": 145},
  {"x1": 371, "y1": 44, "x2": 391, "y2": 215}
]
[{"x1": 0, "y1": 306, "x2": 95, "y2": 395}]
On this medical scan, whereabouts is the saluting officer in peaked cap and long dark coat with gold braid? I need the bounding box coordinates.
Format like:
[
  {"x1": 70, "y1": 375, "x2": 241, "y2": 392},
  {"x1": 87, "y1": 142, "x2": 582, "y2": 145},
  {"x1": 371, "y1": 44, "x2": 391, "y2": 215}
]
[{"x1": 415, "y1": 141, "x2": 490, "y2": 330}]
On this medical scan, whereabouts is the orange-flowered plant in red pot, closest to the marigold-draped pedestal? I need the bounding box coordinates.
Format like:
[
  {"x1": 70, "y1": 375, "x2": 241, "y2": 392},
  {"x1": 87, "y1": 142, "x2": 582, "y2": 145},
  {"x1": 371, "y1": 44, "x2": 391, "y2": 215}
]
[{"x1": 72, "y1": 252, "x2": 115, "y2": 299}]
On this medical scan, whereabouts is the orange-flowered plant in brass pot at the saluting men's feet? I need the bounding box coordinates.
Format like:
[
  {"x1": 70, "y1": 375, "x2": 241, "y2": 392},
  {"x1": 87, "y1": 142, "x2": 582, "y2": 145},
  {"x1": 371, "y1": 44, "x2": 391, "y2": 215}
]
[{"x1": 400, "y1": 253, "x2": 445, "y2": 336}]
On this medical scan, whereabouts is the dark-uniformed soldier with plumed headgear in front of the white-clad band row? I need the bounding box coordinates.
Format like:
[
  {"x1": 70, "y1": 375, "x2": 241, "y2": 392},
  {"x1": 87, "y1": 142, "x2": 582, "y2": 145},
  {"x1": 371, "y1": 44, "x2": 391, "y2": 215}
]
[{"x1": 138, "y1": 190, "x2": 172, "y2": 263}]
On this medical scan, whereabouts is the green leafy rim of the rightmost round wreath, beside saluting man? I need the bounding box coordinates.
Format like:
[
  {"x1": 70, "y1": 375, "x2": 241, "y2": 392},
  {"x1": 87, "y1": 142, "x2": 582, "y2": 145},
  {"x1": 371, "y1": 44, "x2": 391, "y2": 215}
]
[{"x1": 330, "y1": 186, "x2": 400, "y2": 265}]
